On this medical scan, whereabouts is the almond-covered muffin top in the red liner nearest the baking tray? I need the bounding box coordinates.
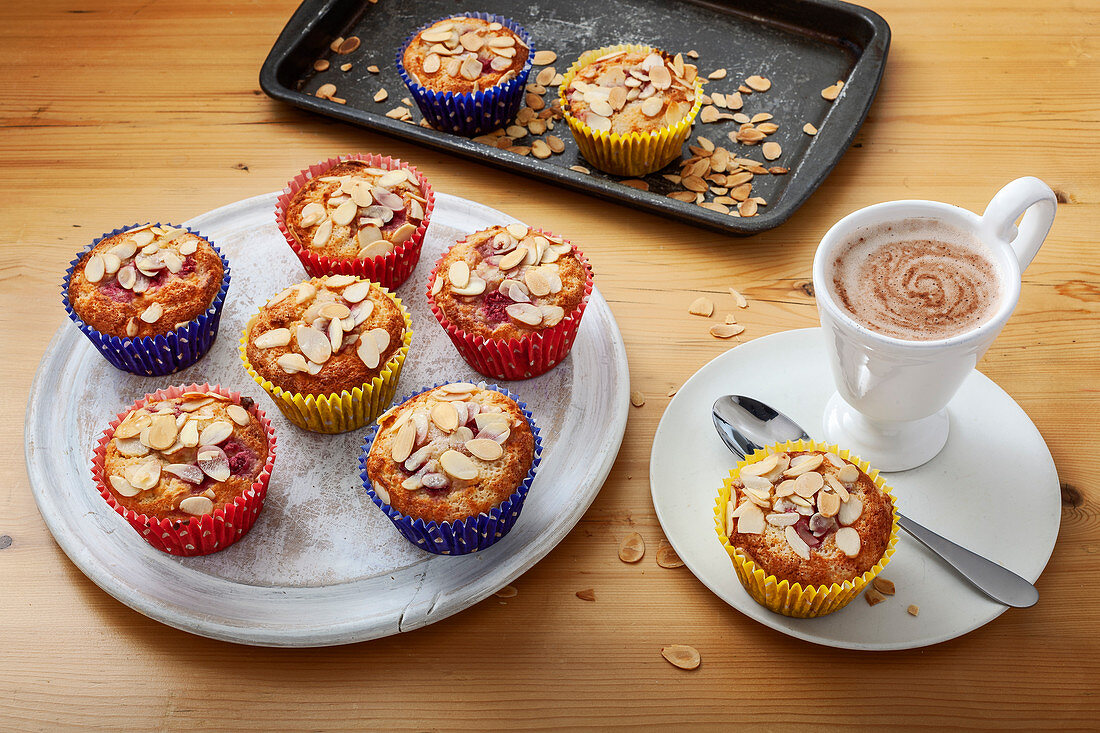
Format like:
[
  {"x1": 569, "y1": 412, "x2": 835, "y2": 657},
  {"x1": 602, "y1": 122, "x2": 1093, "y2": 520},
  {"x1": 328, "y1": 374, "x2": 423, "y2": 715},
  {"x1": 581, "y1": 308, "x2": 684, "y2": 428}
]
[{"x1": 286, "y1": 161, "x2": 428, "y2": 260}]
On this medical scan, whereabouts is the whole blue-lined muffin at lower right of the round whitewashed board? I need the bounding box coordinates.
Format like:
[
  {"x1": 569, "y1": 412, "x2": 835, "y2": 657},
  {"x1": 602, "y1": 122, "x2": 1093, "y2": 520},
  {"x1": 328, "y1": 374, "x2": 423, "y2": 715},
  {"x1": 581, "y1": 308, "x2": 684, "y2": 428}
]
[{"x1": 360, "y1": 382, "x2": 541, "y2": 554}]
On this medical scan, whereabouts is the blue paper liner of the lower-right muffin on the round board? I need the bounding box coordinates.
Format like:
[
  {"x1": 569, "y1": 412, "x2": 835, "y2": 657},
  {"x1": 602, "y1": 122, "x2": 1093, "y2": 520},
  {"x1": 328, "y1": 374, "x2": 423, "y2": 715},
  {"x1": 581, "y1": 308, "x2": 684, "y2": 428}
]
[{"x1": 359, "y1": 382, "x2": 542, "y2": 555}]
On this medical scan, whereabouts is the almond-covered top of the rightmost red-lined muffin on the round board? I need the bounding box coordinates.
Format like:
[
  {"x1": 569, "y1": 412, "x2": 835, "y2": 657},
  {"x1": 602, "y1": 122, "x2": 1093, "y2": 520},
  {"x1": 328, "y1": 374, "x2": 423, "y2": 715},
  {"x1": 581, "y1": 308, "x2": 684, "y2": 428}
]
[{"x1": 430, "y1": 223, "x2": 589, "y2": 339}]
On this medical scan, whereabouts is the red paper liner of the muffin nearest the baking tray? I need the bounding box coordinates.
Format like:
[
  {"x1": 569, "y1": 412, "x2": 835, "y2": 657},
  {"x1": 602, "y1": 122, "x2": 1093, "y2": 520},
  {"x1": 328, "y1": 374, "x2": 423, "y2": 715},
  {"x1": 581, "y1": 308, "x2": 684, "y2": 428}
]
[{"x1": 275, "y1": 153, "x2": 436, "y2": 289}]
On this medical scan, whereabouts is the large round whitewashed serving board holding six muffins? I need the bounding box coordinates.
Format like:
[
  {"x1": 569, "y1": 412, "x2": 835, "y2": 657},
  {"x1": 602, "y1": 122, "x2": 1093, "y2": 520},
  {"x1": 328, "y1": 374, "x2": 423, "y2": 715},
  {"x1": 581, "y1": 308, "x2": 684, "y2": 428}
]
[{"x1": 25, "y1": 194, "x2": 629, "y2": 646}]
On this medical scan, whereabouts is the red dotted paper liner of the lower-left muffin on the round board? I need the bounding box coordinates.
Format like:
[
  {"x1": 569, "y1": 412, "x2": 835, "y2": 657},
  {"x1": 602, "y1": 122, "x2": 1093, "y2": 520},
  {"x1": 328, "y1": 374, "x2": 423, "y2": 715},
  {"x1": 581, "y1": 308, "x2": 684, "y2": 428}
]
[{"x1": 91, "y1": 384, "x2": 275, "y2": 557}]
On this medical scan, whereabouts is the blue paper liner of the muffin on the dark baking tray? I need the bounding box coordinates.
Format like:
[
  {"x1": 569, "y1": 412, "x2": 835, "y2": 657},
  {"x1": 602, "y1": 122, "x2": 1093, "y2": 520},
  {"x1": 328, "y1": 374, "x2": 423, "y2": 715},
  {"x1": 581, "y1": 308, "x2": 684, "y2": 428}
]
[{"x1": 397, "y1": 12, "x2": 535, "y2": 136}]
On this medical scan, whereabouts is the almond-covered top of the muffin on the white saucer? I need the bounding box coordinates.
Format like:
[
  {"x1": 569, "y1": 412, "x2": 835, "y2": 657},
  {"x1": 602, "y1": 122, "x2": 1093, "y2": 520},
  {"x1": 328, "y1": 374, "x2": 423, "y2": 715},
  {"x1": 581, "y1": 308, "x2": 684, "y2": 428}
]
[{"x1": 726, "y1": 450, "x2": 893, "y2": 587}]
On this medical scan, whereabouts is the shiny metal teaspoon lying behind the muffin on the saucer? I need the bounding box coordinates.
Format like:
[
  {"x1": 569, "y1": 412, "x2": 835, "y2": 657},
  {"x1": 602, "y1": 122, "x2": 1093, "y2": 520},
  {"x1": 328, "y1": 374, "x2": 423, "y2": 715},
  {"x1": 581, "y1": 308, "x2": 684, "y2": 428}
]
[{"x1": 711, "y1": 394, "x2": 1038, "y2": 609}]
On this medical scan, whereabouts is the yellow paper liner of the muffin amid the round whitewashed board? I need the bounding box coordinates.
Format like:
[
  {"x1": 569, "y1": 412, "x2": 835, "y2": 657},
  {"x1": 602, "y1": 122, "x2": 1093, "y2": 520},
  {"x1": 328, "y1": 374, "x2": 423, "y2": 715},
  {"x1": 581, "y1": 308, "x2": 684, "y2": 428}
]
[{"x1": 240, "y1": 286, "x2": 413, "y2": 434}]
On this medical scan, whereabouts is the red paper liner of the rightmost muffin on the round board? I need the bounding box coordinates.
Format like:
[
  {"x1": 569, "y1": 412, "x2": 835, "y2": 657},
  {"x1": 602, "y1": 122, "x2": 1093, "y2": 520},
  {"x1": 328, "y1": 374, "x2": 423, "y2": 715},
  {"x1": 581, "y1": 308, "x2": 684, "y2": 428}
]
[{"x1": 427, "y1": 227, "x2": 592, "y2": 380}]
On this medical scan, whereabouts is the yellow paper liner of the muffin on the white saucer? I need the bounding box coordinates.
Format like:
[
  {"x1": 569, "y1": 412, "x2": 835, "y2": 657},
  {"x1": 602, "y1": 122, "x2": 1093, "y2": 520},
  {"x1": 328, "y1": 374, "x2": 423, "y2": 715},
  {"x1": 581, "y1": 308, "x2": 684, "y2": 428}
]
[{"x1": 714, "y1": 440, "x2": 898, "y2": 619}]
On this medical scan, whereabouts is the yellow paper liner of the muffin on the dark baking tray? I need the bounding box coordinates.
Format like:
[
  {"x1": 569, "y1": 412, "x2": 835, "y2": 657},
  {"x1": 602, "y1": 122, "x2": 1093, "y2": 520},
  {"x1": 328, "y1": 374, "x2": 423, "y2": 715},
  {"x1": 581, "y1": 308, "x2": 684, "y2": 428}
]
[{"x1": 558, "y1": 43, "x2": 703, "y2": 176}]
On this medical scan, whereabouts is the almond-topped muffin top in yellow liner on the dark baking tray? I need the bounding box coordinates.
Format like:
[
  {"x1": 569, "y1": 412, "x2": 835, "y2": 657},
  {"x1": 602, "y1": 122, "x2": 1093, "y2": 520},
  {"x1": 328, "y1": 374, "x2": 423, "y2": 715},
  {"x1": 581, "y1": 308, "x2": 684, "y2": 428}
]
[{"x1": 565, "y1": 50, "x2": 697, "y2": 135}]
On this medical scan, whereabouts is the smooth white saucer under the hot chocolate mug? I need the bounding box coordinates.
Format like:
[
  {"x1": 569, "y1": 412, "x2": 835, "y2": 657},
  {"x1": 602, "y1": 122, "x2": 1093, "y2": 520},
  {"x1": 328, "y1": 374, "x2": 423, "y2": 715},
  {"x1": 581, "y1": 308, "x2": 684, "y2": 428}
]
[{"x1": 650, "y1": 328, "x2": 1062, "y2": 649}]
